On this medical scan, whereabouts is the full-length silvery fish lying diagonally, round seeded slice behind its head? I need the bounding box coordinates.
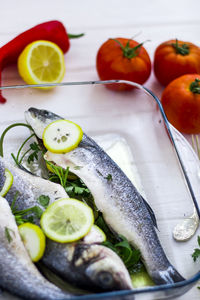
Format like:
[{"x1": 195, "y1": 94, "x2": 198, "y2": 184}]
[{"x1": 25, "y1": 108, "x2": 184, "y2": 284}]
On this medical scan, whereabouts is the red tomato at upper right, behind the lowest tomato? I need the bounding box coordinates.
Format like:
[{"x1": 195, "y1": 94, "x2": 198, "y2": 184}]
[{"x1": 154, "y1": 40, "x2": 200, "y2": 85}]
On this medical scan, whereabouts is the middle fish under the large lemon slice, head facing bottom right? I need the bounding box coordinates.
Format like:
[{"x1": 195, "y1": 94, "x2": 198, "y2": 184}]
[{"x1": 0, "y1": 157, "x2": 132, "y2": 292}]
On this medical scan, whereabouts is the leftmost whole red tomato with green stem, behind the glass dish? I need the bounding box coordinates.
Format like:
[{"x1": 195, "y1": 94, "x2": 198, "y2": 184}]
[{"x1": 96, "y1": 38, "x2": 151, "y2": 90}]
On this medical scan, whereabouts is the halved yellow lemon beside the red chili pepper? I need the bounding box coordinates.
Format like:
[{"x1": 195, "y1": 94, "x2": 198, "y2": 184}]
[{"x1": 18, "y1": 40, "x2": 65, "y2": 84}]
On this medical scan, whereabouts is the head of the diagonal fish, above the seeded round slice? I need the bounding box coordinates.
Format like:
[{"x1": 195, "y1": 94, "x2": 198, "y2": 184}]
[{"x1": 25, "y1": 107, "x2": 62, "y2": 139}]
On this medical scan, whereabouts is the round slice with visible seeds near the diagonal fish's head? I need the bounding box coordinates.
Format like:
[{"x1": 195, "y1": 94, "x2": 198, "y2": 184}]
[{"x1": 42, "y1": 120, "x2": 83, "y2": 153}]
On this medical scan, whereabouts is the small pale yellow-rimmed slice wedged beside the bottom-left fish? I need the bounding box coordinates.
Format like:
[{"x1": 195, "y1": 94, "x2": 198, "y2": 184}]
[{"x1": 18, "y1": 222, "x2": 46, "y2": 262}]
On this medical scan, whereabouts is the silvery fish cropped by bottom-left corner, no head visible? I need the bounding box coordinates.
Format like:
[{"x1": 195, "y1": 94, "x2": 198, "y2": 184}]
[{"x1": 0, "y1": 197, "x2": 70, "y2": 300}]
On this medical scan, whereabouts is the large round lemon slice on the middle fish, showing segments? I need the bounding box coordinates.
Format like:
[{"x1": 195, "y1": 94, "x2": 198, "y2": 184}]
[{"x1": 40, "y1": 198, "x2": 94, "y2": 243}]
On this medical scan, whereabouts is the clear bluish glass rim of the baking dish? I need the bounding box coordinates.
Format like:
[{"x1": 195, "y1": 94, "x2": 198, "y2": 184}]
[{"x1": 0, "y1": 79, "x2": 200, "y2": 300}]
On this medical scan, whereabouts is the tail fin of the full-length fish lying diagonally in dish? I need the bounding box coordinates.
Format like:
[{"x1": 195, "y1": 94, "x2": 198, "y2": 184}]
[{"x1": 152, "y1": 265, "x2": 185, "y2": 285}]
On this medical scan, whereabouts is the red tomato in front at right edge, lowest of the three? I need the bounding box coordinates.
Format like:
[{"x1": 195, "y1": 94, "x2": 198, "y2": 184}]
[{"x1": 161, "y1": 74, "x2": 200, "y2": 134}]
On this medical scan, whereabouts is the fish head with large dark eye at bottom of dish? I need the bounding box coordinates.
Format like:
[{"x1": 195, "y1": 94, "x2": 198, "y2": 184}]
[{"x1": 74, "y1": 244, "x2": 132, "y2": 291}]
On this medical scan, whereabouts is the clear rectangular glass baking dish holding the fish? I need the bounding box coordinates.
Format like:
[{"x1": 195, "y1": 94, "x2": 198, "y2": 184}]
[{"x1": 0, "y1": 80, "x2": 200, "y2": 300}]
